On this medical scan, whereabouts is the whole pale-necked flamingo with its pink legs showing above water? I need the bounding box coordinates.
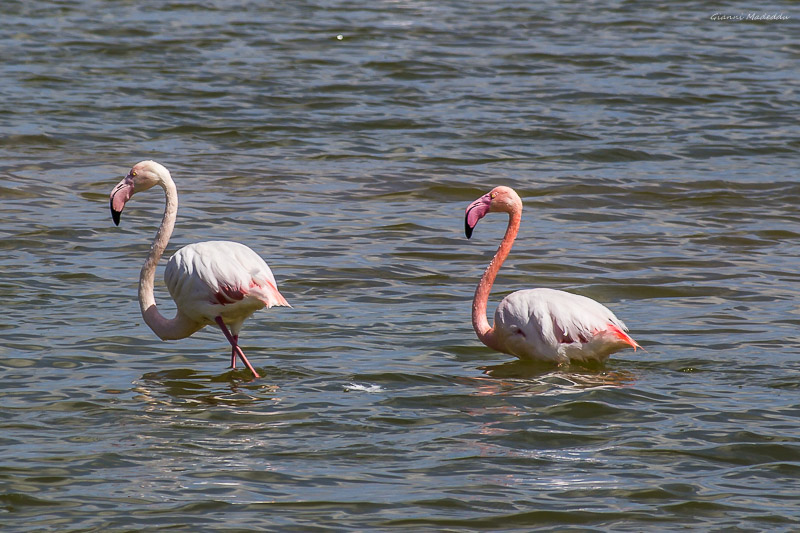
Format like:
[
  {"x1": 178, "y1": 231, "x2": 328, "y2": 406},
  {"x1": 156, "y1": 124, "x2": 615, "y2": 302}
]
[{"x1": 110, "y1": 161, "x2": 291, "y2": 378}]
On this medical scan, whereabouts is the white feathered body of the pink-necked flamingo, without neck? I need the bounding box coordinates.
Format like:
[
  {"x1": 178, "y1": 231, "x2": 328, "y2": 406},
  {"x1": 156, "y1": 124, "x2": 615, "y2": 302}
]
[{"x1": 494, "y1": 289, "x2": 639, "y2": 363}]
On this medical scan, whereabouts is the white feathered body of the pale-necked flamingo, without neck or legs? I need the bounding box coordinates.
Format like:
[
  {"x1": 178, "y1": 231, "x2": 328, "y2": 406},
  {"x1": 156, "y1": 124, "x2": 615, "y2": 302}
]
[{"x1": 164, "y1": 241, "x2": 288, "y2": 324}]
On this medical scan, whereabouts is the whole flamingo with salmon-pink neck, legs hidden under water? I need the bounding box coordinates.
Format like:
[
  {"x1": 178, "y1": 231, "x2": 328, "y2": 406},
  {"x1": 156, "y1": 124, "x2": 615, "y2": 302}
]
[{"x1": 464, "y1": 186, "x2": 640, "y2": 365}]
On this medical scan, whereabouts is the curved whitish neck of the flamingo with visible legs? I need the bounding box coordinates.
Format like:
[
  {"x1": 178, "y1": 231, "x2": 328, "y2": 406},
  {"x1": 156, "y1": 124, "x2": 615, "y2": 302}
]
[{"x1": 139, "y1": 176, "x2": 202, "y2": 340}]
